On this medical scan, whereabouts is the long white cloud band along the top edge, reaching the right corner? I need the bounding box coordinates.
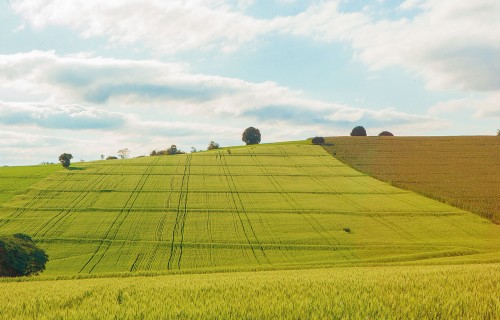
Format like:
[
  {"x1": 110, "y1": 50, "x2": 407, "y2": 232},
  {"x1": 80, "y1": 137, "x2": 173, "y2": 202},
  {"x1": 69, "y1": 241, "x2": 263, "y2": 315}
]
[{"x1": 12, "y1": 0, "x2": 500, "y2": 91}]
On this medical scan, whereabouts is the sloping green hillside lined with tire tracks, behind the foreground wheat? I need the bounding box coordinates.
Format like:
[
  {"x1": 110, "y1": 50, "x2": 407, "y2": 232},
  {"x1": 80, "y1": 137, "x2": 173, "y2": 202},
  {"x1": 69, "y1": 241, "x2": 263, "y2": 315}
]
[{"x1": 0, "y1": 144, "x2": 500, "y2": 275}]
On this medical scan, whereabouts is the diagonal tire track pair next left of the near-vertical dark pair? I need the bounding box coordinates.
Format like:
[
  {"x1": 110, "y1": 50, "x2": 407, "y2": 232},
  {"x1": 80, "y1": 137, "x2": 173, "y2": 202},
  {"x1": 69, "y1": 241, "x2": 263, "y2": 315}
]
[{"x1": 78, "y1": 159, "x2": 158, "y2": 273}]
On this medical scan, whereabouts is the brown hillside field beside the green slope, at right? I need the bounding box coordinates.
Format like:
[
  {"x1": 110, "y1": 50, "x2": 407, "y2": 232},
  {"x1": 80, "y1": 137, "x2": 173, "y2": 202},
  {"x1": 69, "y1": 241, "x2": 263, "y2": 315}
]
[{"x1": 325, "y1": 136, "x2": 500, "y2": 224}]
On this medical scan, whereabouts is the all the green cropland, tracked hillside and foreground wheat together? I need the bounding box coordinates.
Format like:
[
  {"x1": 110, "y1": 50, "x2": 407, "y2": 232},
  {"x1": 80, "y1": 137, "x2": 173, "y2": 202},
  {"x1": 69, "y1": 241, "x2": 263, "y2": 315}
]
[{"x1": 0, "y1": 143, "x2": 500, "y2": 319}]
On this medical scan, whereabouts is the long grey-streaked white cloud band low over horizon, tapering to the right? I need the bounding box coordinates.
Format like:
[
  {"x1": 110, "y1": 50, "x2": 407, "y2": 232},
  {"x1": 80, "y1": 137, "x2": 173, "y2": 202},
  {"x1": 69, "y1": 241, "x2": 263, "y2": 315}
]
[{"x1": 0, "y1": 51, "x2": 441, "y2": 153}]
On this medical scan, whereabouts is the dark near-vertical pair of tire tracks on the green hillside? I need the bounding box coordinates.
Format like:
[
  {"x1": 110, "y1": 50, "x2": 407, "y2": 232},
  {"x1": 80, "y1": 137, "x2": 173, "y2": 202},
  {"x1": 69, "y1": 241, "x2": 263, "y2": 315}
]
[{"x1": 167, "y1": 154, "x2": 192, "y2": 270}]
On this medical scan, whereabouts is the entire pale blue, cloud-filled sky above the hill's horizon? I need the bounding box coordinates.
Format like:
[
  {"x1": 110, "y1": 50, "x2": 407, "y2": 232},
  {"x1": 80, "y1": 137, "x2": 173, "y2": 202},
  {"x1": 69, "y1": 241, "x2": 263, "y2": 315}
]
[{"x1": 0, "y1": 0, "x2": 500, "y2": 165}]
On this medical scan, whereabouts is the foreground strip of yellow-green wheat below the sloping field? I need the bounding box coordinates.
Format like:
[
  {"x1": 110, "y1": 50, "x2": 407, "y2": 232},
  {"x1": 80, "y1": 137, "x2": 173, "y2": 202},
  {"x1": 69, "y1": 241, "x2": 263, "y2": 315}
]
[{"x1": 0, "y1": 264, "x2": 500, "y2": 319}]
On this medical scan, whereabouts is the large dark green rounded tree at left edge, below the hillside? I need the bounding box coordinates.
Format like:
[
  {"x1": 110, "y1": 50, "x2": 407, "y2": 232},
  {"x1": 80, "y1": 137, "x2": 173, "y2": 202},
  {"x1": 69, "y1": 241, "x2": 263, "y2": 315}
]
[{"x1": 0, "y1": 233, "x2": 49, "y2": 277}]
